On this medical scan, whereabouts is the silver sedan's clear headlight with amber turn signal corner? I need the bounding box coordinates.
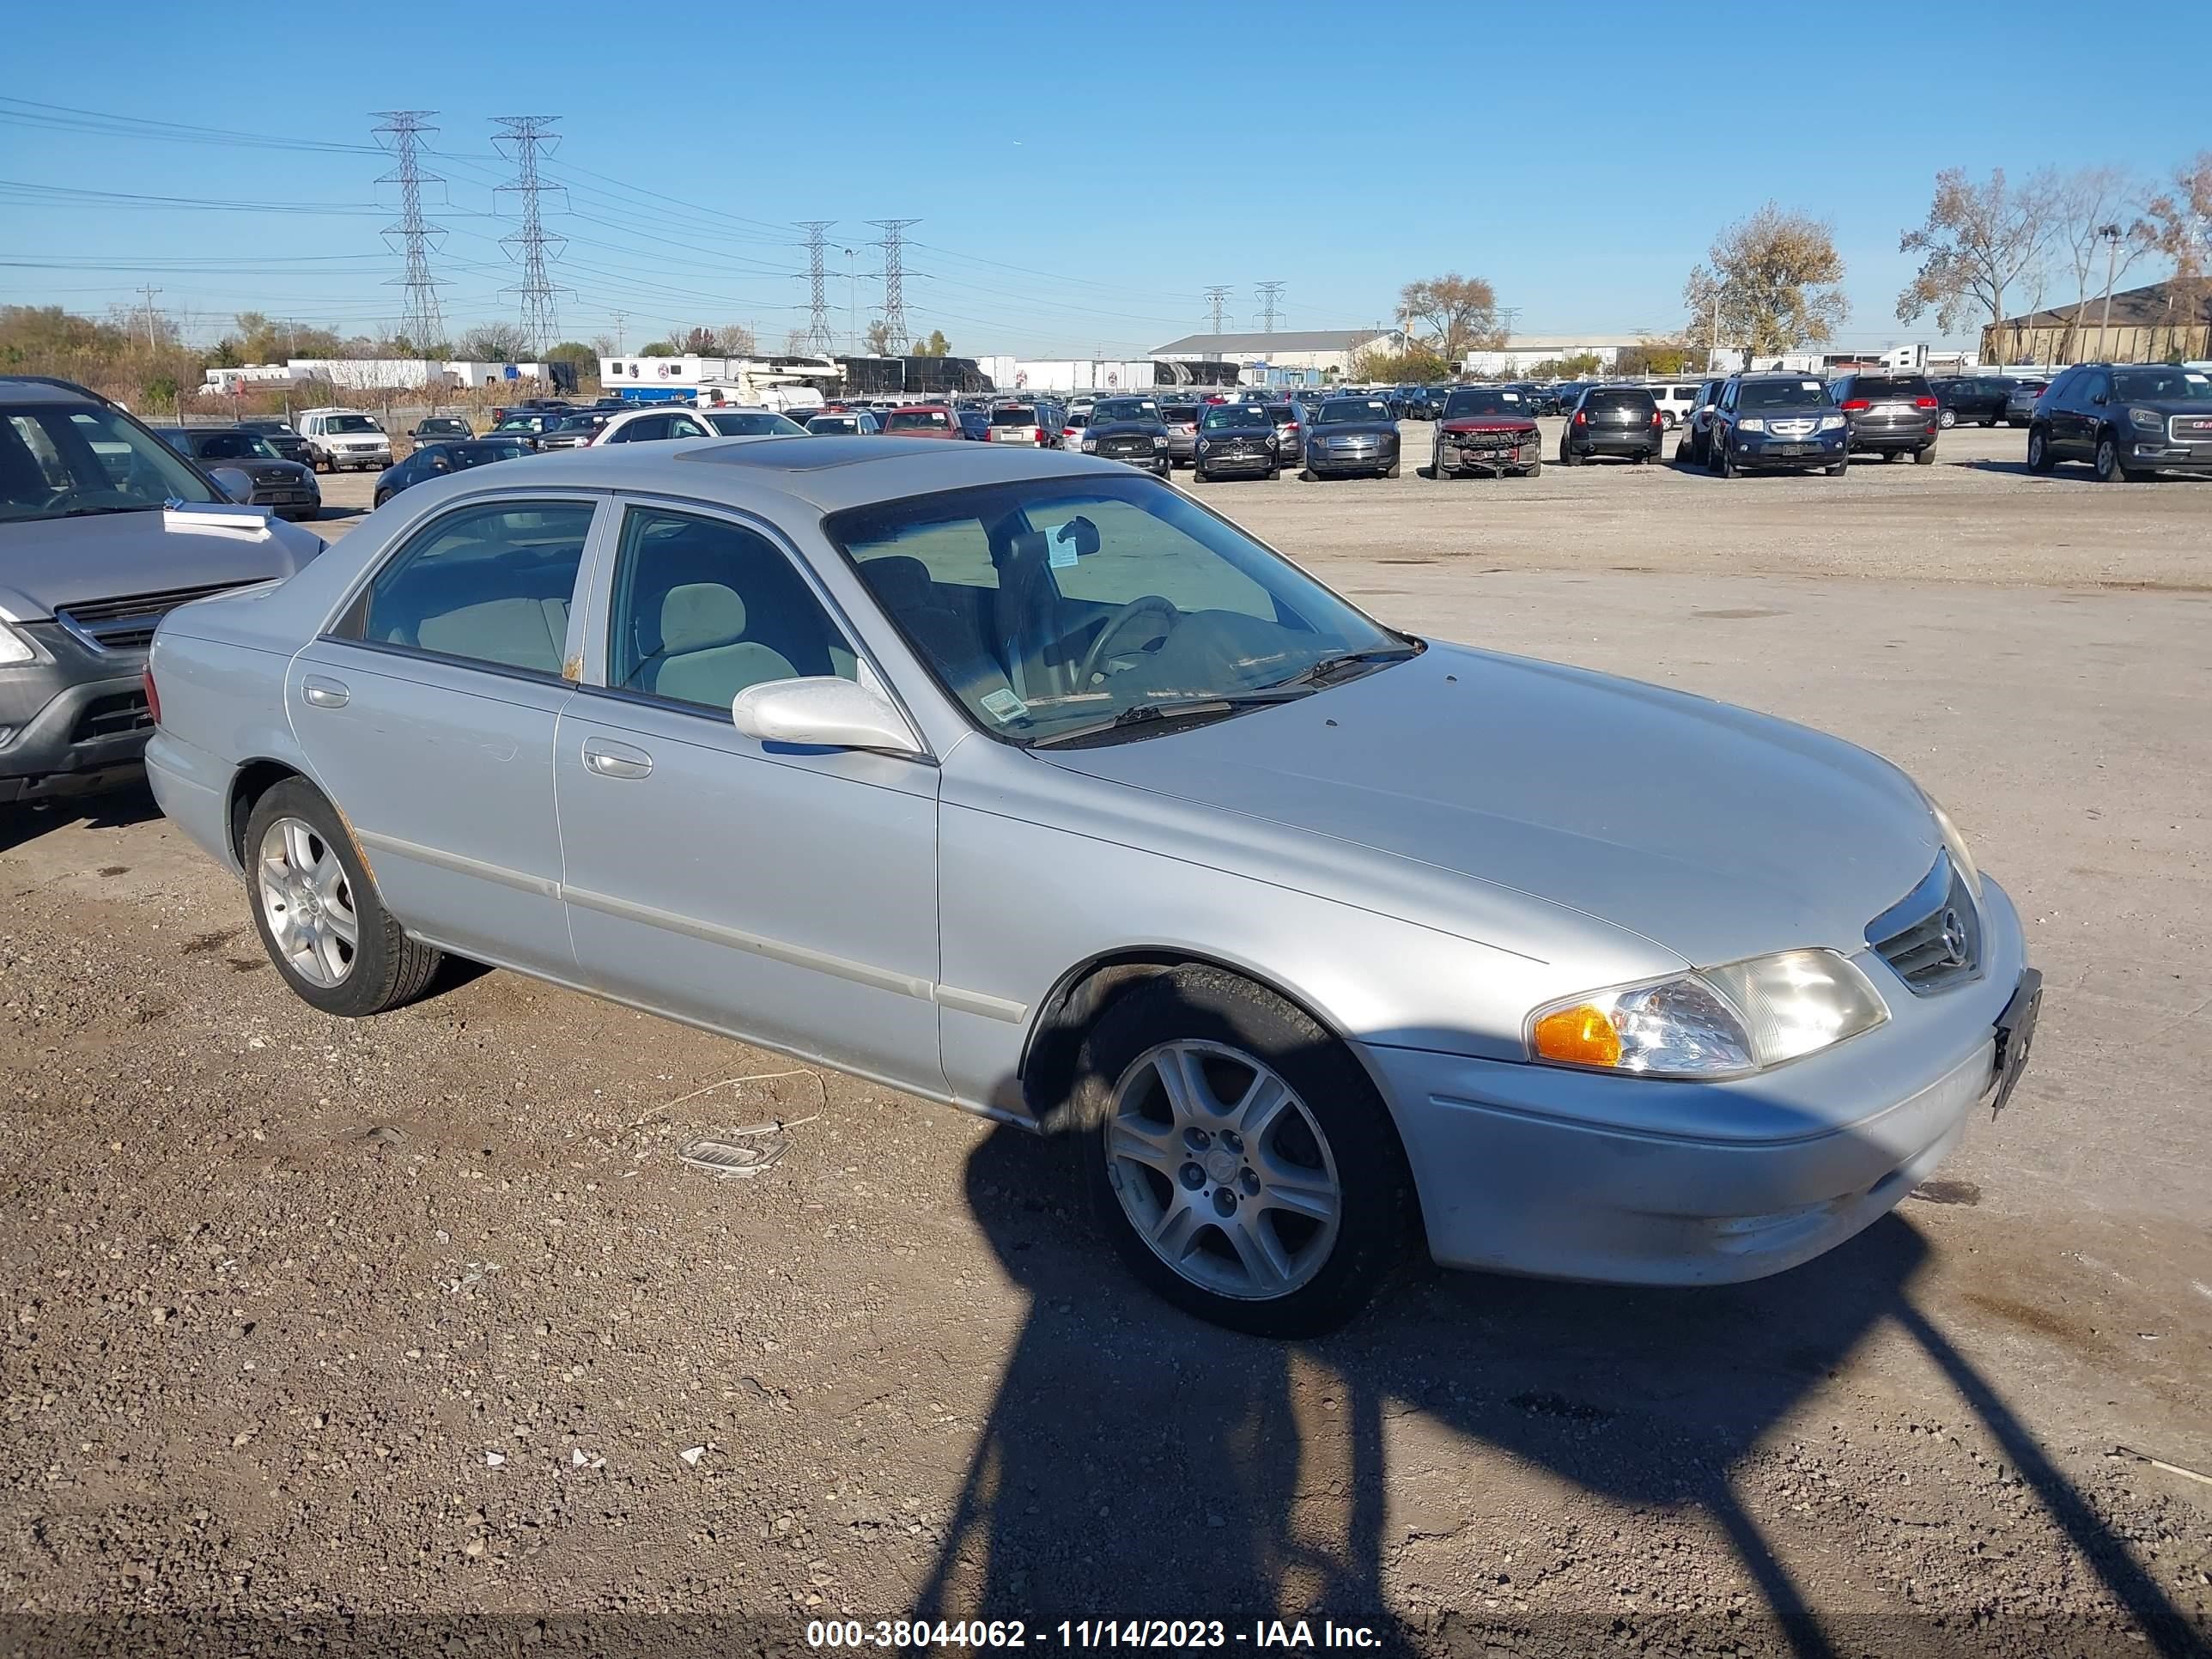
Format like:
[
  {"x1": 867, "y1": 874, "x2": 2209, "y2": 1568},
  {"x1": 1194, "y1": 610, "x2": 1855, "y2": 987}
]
[{"x1": 1528, "y1": 951, "x2": 1889, "y2": 1078}]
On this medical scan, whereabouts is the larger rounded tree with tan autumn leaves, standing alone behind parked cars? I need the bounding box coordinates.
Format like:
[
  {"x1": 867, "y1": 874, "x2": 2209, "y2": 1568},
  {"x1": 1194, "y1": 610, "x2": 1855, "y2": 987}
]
[{"x1": 1681, "y1": 201, "x2": 1851, "y2": 354}]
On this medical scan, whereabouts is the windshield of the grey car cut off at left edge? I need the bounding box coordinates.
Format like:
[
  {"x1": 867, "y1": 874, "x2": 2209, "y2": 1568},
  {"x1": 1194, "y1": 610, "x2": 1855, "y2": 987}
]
[{"x1": 0, "y1": 403, "x2": 223, "y2": 520}]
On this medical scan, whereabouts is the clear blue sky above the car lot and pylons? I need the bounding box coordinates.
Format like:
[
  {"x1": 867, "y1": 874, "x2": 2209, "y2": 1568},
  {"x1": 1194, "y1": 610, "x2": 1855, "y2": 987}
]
[{"x1": 0, "y1": 0, "x2": 2212, "y2": 356}]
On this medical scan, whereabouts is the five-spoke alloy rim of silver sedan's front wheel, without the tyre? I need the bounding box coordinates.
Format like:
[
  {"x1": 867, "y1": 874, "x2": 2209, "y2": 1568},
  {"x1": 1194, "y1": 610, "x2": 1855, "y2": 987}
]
[{"x1": 1103, "y1": 1040, "x2": 1345, "y2": 1301}]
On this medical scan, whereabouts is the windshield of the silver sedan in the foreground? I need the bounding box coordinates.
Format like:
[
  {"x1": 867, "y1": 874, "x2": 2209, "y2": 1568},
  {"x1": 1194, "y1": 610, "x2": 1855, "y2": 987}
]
[{"x1": 823, "y1": 477, "x2": 1413, "y2": 744}]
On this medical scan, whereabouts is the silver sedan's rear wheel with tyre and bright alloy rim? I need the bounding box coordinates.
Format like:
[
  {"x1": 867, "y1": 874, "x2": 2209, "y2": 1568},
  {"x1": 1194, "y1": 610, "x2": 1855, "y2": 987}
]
[{"x1": 241, "y1": 779, "x2": 442, "y2": 1020}]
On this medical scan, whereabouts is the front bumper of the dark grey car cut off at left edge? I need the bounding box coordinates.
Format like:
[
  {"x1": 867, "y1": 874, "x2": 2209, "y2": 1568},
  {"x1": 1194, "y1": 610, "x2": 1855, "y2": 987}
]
[{"x1": 0, "y1": 622, "x2": 153, "y2": 801}]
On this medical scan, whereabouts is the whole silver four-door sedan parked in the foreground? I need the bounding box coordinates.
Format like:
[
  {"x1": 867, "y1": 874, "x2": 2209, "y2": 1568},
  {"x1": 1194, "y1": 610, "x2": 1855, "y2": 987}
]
[{"x1": 146, "y1": 438, "x2": 2039, "y2": 1334}]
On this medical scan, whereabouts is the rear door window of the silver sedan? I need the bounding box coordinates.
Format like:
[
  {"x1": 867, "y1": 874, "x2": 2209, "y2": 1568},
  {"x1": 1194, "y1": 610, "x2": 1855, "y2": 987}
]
[{"x1": 337, "y1": 502, "x2": 592, "y2": 679}]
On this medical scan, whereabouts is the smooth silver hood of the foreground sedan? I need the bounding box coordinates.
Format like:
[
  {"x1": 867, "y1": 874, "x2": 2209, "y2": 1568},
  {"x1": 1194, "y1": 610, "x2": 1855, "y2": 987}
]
[{"x1": 1040, "y1": 646, "x2": 1940, "y2": 967}]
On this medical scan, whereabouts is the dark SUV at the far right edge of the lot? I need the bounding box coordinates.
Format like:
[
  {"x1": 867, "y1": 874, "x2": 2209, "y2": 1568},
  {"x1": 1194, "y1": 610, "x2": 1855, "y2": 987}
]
[{"x1": 2028, "y1": 362, "x2": 2212, "y2": 484}]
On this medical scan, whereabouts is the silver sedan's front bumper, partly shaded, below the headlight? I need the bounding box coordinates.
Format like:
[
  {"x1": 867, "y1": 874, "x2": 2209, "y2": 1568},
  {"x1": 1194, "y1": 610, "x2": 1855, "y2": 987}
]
[{"x1": 1360, "y1": 880, "x2": 2027, "y2": 1285}]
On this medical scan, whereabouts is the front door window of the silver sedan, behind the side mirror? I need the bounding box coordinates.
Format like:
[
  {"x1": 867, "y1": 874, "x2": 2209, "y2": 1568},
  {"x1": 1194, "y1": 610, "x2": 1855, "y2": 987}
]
[{"x1": 606, "y1": 507, "x2": 858, "y2": 714}]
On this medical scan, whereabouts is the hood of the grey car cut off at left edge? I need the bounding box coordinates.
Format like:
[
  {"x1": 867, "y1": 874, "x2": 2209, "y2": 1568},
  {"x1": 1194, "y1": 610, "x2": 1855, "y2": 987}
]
[{"x1": 0, "y1": 506, "x2": 323, "y2": 622}]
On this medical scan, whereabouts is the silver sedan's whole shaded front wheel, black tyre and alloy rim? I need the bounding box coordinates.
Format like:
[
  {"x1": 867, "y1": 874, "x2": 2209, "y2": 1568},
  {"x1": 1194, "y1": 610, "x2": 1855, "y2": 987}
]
[{"x1": 1073, "y1": 967, "x2": 1413, "y2": 1336}]
